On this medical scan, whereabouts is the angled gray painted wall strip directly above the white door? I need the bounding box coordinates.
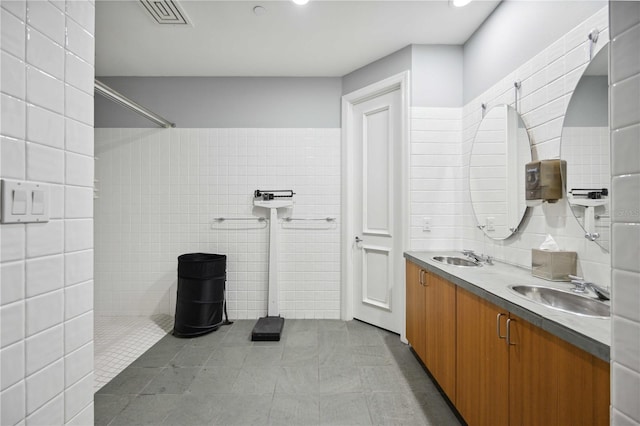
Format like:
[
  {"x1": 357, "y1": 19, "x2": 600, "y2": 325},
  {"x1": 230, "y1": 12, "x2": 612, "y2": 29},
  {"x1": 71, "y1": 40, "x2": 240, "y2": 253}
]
[{"x1": 342, "y1": 46, "x2": 411, "y2": 95}]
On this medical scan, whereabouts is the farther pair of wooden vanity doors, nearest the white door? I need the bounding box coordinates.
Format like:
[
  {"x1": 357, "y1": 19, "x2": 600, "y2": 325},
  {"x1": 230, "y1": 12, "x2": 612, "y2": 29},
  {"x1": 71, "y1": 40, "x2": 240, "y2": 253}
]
[{"x1": 406, "y1": 261, "x2": 456, "y2": 401}]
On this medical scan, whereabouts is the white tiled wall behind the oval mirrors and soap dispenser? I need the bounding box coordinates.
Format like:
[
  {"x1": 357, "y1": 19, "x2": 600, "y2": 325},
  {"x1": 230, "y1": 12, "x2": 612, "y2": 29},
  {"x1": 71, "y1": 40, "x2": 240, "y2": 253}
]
[{"x1": 462, "y1": 8, "x2": 610, "y2": 285}]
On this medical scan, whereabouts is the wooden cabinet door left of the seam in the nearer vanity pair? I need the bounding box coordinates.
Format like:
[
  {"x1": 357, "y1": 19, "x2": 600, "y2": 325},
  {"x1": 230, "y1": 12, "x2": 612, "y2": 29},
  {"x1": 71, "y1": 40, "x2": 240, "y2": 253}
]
[{"x1": 455, "y1": 288, "x2": 509, "y2": 426}]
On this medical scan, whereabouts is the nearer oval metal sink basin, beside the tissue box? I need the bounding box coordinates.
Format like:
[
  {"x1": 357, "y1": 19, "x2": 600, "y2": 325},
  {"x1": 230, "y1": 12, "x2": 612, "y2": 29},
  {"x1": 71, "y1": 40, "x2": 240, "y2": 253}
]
[{"x1": 509, "y1": 285, "x2": 611, "y2": 318}]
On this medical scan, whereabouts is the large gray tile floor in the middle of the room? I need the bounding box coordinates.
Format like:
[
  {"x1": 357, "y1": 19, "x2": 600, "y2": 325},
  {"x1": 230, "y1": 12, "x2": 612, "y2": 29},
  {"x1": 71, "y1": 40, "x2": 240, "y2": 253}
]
[{"x1": 95, "y1": 320, "x2": 460, "y2": 426}]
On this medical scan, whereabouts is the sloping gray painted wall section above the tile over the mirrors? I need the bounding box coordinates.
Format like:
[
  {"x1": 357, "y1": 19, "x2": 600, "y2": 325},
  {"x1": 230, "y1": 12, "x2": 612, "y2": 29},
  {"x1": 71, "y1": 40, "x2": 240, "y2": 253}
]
[{"x1": 464, "y1": 0, "x2": 607, "y2": 103}]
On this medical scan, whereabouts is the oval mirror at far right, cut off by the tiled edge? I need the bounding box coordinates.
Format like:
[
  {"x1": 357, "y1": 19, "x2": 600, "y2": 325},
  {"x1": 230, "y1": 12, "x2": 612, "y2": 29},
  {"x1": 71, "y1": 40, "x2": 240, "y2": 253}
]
[{"x1": 560, "y1": 45, "x2": 611, "y2": 251}]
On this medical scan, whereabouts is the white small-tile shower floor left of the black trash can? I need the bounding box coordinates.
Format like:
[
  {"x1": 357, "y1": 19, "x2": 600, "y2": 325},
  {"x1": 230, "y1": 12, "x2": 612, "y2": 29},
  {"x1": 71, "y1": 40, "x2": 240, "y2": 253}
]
[{"x1": 93, "y1": 314, "x2": 173, "y2": 392}]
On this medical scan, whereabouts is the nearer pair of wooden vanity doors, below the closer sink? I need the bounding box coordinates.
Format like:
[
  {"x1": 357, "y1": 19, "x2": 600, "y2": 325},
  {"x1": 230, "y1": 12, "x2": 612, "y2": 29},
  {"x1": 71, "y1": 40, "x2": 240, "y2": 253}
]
[{"x1": 455, "y1": 288, "x2": 609, "y2": 426}]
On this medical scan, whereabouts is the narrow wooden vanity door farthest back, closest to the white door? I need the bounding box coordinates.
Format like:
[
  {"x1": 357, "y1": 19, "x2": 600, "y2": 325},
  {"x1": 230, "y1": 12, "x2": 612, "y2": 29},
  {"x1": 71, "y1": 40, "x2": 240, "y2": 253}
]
[{"x1": 406, "y1": 261, "x2": 425, "y2": 362}]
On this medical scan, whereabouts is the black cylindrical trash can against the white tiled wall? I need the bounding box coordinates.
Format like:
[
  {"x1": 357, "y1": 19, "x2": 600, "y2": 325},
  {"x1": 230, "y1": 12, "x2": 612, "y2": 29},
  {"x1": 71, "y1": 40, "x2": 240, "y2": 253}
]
[{"x1": 173, "y1": 253, "x2": 227, "y2": 337}]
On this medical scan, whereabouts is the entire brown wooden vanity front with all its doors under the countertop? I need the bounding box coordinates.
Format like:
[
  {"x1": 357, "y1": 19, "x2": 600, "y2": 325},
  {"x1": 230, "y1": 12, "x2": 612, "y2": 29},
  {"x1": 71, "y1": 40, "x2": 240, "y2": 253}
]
[{"x1": 407, "y1": 262, "x2": 610, "y2": 426}]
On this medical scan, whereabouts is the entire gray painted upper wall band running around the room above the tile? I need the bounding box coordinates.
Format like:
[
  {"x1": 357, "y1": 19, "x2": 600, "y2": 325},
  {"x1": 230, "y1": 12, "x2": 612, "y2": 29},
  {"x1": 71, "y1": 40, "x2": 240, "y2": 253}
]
[{"x1": 95, "y1": 0, "x2": 607, "y2": 128}]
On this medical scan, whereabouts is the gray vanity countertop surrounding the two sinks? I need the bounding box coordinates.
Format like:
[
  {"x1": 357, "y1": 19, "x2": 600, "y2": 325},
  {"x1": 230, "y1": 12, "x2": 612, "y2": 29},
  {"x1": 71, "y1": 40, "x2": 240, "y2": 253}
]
[{"x1": 404, "y1": 251, "x2": 611, "y2": 362}]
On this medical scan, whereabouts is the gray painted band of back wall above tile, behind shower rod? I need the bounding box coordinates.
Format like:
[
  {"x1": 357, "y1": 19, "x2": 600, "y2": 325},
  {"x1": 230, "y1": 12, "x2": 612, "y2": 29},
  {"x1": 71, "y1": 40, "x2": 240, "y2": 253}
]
[{"x1": 95, "y1": 77, "x2": 342, "y2": 128}]
